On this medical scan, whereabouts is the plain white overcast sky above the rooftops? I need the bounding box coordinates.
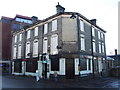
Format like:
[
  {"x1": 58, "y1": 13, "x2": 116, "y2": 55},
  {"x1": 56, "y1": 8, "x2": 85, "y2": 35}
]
[{"x1": 0, "y1": 0, "x2": 119, "y2": 55}]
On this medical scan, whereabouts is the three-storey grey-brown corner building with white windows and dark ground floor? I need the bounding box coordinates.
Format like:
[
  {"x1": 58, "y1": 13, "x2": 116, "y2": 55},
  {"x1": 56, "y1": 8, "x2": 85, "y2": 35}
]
[{"x1": 12, "y1": 4, "x2": 106, "y2": 78}]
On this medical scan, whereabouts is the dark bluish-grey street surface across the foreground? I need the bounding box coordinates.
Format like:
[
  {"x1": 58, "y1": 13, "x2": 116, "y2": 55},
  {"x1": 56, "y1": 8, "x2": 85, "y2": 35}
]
[{"x1": 2, "y1": 75, "x2": 120, "y2": 90}]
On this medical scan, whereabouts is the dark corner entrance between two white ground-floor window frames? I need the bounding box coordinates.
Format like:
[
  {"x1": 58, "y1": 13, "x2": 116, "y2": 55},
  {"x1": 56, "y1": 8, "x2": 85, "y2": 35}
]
[{"x1": 66, "y1": 58, "x2": 75, "y2": 79}]
